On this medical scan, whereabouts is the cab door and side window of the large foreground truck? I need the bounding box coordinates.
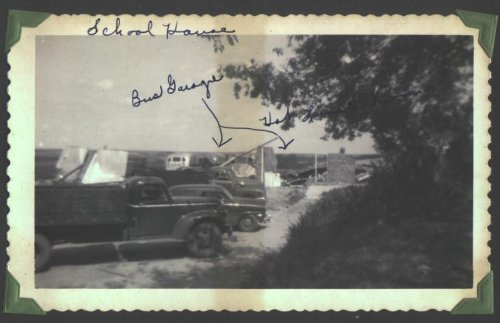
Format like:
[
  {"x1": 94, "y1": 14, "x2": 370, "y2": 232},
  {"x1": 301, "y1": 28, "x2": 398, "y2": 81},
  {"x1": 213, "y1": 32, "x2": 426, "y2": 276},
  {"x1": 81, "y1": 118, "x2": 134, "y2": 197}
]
[{"x1": 128, "y1": 183, "x2": 183, "y2": 239}]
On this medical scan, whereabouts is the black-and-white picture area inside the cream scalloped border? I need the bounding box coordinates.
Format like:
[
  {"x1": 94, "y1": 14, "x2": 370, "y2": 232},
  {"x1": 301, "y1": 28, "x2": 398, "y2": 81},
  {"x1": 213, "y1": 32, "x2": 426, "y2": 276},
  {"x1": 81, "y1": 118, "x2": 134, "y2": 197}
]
[{"x1": 33, "y1": 32, "x2": 474, "y2": 289}]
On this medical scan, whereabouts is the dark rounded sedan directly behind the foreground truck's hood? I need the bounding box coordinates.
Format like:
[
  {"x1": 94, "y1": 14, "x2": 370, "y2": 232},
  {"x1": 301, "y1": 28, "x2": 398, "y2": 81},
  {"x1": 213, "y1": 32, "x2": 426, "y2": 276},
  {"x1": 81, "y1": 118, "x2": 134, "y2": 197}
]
[{"x1": 169, "y1": 184, "x2": 271, "y2": 232}]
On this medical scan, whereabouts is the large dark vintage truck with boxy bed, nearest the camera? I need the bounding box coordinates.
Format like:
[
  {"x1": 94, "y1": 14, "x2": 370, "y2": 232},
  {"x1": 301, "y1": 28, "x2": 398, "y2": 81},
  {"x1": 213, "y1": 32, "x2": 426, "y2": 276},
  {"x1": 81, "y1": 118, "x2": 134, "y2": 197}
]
[{"x1": 35, "y1": 177, "x2": 231, "y2": 271}]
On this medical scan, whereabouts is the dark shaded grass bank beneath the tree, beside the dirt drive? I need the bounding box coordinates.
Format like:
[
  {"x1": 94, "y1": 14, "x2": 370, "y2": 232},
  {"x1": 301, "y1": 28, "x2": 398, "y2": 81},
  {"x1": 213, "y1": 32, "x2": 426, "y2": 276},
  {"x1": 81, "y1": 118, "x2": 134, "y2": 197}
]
[{"x1": 243, "y1": 173, "x2": 472, "y2": 288}]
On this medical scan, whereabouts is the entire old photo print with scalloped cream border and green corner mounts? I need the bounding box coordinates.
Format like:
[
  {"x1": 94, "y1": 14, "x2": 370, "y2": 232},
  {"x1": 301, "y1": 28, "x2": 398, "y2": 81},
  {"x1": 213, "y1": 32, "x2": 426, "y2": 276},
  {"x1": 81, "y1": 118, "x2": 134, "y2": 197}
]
[{"x1": 5, "y1": 11, "x2": 496, "y2": 314}]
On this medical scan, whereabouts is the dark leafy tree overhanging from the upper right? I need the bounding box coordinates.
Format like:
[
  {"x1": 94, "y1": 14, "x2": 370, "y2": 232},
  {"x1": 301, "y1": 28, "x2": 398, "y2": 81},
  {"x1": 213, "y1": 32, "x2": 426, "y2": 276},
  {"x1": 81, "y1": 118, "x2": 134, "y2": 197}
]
[{"x1": 222, "y1": 36, "x2": 473, "y2": 187}]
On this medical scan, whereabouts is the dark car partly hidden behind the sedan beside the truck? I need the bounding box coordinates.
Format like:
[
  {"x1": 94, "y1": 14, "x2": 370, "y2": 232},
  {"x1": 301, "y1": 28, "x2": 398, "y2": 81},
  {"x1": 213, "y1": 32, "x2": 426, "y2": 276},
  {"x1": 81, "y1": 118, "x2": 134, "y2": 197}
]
[{"x1": 208, "y1": 166, "x2": 266, "y2": 200}]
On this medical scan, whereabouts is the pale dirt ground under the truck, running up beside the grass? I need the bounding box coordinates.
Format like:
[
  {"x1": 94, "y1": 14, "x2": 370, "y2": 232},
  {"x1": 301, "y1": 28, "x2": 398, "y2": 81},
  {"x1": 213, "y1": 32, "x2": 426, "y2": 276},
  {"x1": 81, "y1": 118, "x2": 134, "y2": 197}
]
[{"x1": 35, "y1": 187, "x2": 311, "y2": 288}]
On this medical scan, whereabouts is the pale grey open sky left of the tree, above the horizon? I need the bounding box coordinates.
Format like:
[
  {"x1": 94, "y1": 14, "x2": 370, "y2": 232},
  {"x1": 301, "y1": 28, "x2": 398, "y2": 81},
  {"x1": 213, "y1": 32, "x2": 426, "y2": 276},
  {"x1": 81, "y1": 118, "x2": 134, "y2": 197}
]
[{"x1": 35, "y1": 36, "x2": 374, "y2": 154}]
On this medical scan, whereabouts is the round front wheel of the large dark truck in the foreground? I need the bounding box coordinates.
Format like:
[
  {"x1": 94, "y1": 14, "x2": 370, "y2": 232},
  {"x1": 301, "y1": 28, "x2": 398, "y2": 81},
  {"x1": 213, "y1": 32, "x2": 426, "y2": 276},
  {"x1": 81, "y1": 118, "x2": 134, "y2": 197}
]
[{"x1": 188, "y1": 222, "x2": 222, "y2": 258}]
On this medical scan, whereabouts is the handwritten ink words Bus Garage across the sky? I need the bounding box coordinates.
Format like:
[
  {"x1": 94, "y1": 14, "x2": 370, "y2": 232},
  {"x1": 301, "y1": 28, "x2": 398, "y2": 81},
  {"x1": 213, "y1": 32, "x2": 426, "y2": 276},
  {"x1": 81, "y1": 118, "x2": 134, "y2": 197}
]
[{"x1": 132, "y1": 74, "x2": 224, "y2": 108}]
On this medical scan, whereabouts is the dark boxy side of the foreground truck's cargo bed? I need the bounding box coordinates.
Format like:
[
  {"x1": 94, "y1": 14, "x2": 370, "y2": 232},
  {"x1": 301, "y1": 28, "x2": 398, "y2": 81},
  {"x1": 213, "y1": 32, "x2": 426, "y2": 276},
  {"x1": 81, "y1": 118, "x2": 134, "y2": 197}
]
[{"x1": 35, "y1": 183, "x2": 127, "y2": 227}]
